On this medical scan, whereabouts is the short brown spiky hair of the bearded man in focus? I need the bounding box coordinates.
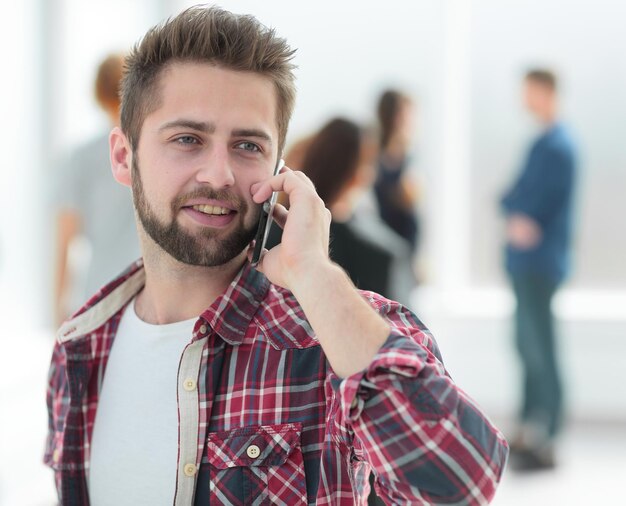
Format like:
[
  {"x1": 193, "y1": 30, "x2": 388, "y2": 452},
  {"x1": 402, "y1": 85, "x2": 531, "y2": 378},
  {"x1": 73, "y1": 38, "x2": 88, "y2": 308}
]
[{"x1": 121, "y1": 6, "x2": 296, "y2": 153}]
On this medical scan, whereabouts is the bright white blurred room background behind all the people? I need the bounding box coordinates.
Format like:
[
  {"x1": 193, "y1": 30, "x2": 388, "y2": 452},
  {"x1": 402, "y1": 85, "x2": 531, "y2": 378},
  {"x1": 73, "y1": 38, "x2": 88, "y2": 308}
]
[{"x1": 0, "y1": 0, "x2": 626, "y2": 506}]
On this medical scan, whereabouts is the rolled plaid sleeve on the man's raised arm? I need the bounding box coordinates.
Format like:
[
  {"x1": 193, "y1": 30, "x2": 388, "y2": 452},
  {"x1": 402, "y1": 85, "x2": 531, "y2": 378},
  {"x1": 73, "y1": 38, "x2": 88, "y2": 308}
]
[{"x1": 331, "y1": 302, "x2": 508, "y2": 505}]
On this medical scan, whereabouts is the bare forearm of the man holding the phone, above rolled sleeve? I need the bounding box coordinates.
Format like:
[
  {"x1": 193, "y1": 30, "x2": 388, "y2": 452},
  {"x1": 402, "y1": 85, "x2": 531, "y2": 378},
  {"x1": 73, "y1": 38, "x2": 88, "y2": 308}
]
[{"x1": 291, "y1": 261, "x2": 390, "y2": 377}]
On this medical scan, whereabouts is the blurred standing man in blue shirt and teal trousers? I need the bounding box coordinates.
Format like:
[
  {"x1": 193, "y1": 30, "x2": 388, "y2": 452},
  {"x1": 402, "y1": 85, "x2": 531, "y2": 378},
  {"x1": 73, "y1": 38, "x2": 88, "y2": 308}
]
[{"x1": 502, "y1": 70, "x2": 576, "y2": 470}]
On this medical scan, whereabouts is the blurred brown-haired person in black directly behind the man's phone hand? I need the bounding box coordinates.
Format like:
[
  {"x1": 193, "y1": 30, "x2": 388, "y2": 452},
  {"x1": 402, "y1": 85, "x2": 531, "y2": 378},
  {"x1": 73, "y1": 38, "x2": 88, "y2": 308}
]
[{"x1": 271, "y1": 118, "x2": 415, "y2": 305}]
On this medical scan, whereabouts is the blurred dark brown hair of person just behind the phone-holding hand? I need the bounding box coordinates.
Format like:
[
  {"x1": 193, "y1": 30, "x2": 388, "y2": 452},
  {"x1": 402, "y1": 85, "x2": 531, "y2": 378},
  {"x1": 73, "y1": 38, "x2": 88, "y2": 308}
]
[{"x1": 301, "y1": 118, "x2": 363, "y2": 207}]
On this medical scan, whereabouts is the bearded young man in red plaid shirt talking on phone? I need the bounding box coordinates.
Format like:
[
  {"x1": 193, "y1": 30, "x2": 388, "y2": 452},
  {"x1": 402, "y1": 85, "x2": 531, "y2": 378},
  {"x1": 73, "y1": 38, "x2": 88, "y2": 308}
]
[{"x1": 45, "y1": 8, "x2": 507, "y2": 505}]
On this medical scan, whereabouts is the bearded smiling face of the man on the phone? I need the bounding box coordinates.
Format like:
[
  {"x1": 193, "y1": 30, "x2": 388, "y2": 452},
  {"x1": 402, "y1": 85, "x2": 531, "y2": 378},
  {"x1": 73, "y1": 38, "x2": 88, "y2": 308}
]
[{"x1": 132, "y1": 63, "x2": 278, "y2": 267}]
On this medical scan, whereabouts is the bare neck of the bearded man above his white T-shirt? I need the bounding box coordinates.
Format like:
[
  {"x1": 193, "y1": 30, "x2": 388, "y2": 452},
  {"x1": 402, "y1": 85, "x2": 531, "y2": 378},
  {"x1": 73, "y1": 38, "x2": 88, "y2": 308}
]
[{"x1": 135, "y1": 234, "x2": 246, "y2": 325}]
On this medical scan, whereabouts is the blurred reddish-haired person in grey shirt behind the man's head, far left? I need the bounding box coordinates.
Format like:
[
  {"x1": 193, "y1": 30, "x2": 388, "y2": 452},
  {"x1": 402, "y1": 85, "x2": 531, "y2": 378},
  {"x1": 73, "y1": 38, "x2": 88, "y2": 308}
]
[{"x1": 54, "y1": 54, "x2": 139, "y2": 324}]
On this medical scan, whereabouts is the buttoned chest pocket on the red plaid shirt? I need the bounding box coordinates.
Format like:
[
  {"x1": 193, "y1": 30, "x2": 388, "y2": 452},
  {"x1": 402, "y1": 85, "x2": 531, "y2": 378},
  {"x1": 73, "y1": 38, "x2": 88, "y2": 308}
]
[{"x1": 206, "y1": 423, "x2": 307, "y2": 505}]
